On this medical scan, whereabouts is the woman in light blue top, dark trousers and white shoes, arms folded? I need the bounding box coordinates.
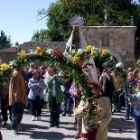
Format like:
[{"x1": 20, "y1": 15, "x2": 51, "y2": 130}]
[{"x1": 28, "y1": 69, "x2": 45, "y2": 121}]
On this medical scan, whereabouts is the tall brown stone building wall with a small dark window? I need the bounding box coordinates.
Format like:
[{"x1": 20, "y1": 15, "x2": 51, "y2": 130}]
[{"x1": 83, "y1": 26, "x2": 136, "y2": 67}]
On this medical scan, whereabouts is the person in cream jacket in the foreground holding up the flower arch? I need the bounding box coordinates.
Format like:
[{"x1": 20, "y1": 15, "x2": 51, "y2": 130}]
[{"x1": 75, "y1": 83, "x2": 111, "y2": 140}]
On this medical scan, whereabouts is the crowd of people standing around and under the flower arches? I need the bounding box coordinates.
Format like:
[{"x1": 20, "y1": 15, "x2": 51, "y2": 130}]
[{"x1": 0, "y1": 63, "x2": 140, "y2": 140}]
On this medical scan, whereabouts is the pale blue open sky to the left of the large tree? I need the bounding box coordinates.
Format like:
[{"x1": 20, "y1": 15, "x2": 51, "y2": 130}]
[{"x1": 0, "y1": 0, "x2": 56, "y2": 44}]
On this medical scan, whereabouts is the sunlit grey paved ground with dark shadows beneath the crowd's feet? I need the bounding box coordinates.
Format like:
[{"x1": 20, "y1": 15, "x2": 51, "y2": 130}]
[{"x1": 2, "y1": 111, "x2": 135, "y2": 140}]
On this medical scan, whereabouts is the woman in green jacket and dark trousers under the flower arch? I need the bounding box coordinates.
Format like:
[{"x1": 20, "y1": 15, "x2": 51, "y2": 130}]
[{"x1": 44, "y1": 67, "x2": 64, "y2": 128}]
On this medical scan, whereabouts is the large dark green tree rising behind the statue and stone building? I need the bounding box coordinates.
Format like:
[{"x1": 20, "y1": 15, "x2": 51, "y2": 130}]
[{"x1": 39, "y1": 0, "x2": 140, "y2": 41}]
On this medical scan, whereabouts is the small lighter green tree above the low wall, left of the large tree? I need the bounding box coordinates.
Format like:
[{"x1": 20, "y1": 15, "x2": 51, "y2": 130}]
[{"x1": 32, "y1": 30, "x2": 49, "y2": 42}]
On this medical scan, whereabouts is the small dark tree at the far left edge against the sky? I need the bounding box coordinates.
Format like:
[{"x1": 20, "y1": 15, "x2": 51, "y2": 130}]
[{"x1": 0, "y1": 31, "x2": 11, "y2": 49}]
